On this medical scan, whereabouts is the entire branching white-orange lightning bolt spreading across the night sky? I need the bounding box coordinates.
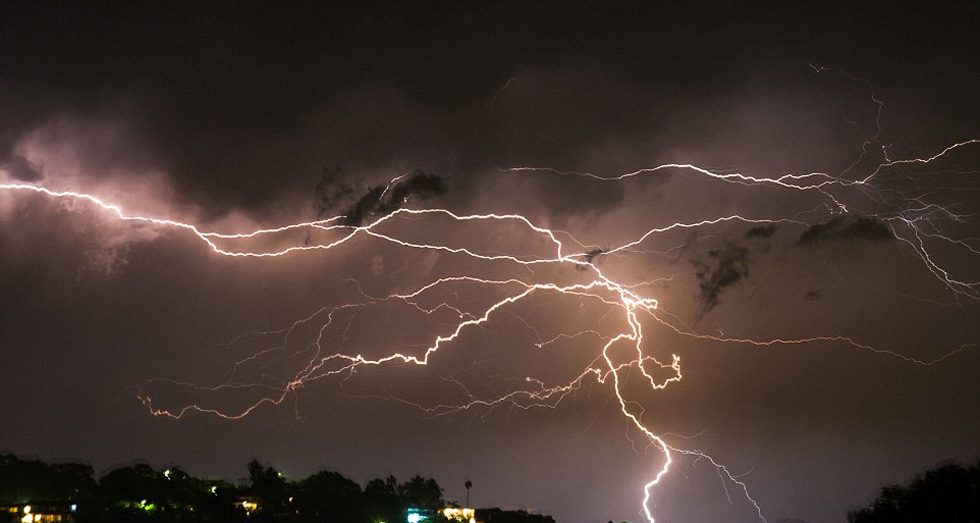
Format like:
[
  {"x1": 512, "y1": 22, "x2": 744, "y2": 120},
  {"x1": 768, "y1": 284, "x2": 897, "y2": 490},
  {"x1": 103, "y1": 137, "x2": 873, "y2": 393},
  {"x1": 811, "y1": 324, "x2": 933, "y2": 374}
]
[{"x1": 0, "y1": 72, "x2": 980, "y2": 523}]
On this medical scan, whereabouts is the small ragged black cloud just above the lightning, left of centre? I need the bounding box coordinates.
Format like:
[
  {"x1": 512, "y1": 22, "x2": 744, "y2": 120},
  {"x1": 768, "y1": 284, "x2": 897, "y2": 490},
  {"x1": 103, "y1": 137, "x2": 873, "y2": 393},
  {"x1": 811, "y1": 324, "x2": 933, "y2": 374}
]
[{"x1": 336, "y1": 170, "x2": 449, "y2": 225}]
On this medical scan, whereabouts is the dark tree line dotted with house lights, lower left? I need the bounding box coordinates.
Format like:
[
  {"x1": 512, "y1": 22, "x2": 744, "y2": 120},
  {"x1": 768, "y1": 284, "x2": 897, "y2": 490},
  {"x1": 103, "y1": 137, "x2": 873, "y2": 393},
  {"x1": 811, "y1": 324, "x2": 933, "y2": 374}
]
[{"x1": 0, "y1": 455, "x2": 466, "y2": 523}]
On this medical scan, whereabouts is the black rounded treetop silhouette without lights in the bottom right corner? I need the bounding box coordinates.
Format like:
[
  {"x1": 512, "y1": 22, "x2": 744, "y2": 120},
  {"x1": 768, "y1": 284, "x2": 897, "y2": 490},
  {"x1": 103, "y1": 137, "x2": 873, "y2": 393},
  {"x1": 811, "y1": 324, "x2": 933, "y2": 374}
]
[{"x1": 847, "y1": 460, "x2": 980, "y2": 523}]
